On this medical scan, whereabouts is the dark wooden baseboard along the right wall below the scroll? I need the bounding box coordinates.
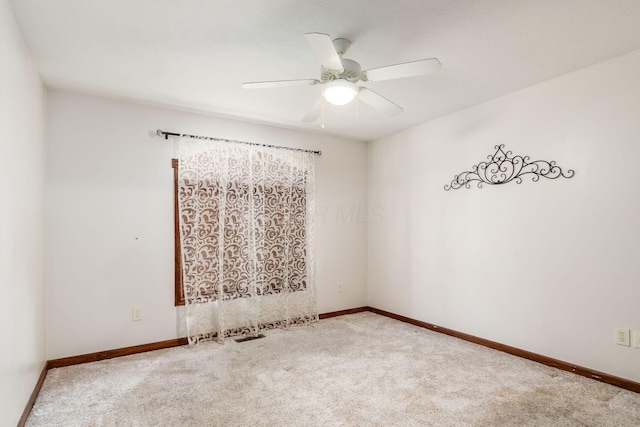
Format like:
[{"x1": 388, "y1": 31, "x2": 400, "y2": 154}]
[{"x1": 369, "y1": 307, "x2": 640, "y2": 393}]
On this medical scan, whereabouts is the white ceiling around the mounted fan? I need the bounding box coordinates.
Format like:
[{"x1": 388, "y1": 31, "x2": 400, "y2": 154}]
[{"x1": 10, "y1": 0, "x2": 640, "y2": 140}]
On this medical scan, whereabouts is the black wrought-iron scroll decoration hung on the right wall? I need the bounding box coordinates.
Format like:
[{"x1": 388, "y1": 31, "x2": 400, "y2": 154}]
[{"x1": 444, "y1": 144, "x2": 575, "y2": 191}]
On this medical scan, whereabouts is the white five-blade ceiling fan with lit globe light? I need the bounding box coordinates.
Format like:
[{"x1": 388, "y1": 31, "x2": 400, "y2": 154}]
[{"x1": 242, "y1": 33, "x2": 441, "y2": 122}]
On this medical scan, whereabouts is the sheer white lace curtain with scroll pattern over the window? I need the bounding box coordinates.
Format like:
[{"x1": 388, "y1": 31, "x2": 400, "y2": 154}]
[{"x1": 178, "y1": 137, "x2": 318, "y2": 344}]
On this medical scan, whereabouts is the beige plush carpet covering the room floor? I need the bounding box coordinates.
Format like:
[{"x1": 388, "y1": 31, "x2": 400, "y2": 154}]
[{"x1": 27, "y1": 313, "x2": 640, "y2": 427}]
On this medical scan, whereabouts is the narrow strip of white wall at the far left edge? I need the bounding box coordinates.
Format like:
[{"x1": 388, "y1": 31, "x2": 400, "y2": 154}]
[{"x1": 0, "y1": 1, "x2": 46, "y2": 426}]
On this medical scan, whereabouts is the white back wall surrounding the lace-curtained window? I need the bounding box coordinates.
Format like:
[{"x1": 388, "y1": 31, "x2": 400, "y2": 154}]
[{"x1": 47, "y1": 91, "x2": 367, "y2": 359}]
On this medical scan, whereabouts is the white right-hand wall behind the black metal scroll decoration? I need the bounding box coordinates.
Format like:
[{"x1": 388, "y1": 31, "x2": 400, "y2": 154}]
[{"x1": 368, "y1": 51, "x2": 640, "y2": 381}]
